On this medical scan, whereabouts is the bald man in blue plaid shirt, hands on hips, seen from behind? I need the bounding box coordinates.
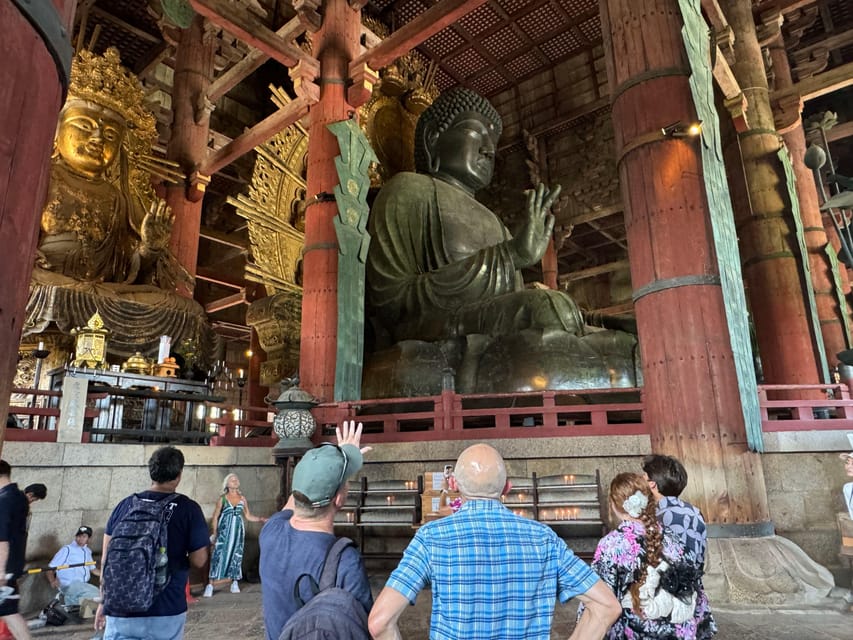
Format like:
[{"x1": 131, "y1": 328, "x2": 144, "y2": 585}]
[{"x1": 369, "y1": 444, "x2": 621, "y2": 640}]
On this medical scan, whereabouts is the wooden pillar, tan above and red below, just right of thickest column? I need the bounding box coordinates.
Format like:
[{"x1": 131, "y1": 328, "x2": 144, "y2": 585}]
[{"x1": 720, "y1": 0, "x2": 821, "y2": 384}]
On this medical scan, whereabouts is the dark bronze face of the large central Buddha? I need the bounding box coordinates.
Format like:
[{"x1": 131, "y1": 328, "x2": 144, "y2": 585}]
[{"x1": 433, "y1": 111, "x2": 497, "y2": 193}]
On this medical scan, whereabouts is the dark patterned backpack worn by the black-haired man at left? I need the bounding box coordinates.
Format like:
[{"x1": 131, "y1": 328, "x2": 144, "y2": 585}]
[{"x1": 102, "y1": 493, "x2": 178, "y2": 614}]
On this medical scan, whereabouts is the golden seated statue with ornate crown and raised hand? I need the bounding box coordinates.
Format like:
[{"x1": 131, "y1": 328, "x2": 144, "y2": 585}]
[{"x1": 25, "y1": 48, "x2": 205, "y2": 356}]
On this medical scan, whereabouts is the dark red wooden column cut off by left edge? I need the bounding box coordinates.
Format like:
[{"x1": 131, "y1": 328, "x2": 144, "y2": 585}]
[{"x1": 0, "y1": 0, "x2": 77, "y2": 450}]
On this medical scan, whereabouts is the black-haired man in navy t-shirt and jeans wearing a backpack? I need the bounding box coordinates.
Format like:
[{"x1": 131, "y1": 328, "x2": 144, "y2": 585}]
[{"x1": 95, "y1": 447, "x2": 210, "y2": 640}]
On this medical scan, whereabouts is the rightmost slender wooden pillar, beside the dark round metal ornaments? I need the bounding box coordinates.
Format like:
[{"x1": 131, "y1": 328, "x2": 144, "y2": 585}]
[{"x1": 765, "y1": 14, "x2": 853, "y2": 368}]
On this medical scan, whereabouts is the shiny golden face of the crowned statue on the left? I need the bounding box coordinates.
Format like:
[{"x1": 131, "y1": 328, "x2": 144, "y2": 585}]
[{"x1": 56, "y1": 100, "x2": 125, "y2": 177}]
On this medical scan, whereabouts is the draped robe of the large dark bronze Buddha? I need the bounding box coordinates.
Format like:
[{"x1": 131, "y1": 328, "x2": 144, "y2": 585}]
[{"x1": 367, "y1": 172, "x2": 583, "y2": 341}]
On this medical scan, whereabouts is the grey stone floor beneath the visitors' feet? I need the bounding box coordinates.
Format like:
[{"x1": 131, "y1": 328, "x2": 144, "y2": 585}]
[{"x1": 32, "y1": 577, "x2": 853, "y2": 640}]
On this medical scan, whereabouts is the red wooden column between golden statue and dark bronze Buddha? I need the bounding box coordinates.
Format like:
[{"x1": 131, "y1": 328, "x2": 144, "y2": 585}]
[{"x1": 299, "y1": 0, "x2": 361, "y2": 400}]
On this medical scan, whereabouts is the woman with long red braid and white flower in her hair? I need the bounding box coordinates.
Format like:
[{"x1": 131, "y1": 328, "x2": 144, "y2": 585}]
[{"x1": 578, "y1": 473, "x2": 709, "y2": 640}]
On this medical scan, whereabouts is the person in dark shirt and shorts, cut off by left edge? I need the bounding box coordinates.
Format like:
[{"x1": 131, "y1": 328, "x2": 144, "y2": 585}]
[{"x1": 0, "y1": 460, "x2": 30, "y2": 640}]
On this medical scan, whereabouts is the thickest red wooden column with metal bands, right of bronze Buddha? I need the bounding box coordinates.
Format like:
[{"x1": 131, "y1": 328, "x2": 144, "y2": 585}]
[{"x1": 600, "y1": 0, "x2": 771, "y2": 537}]
